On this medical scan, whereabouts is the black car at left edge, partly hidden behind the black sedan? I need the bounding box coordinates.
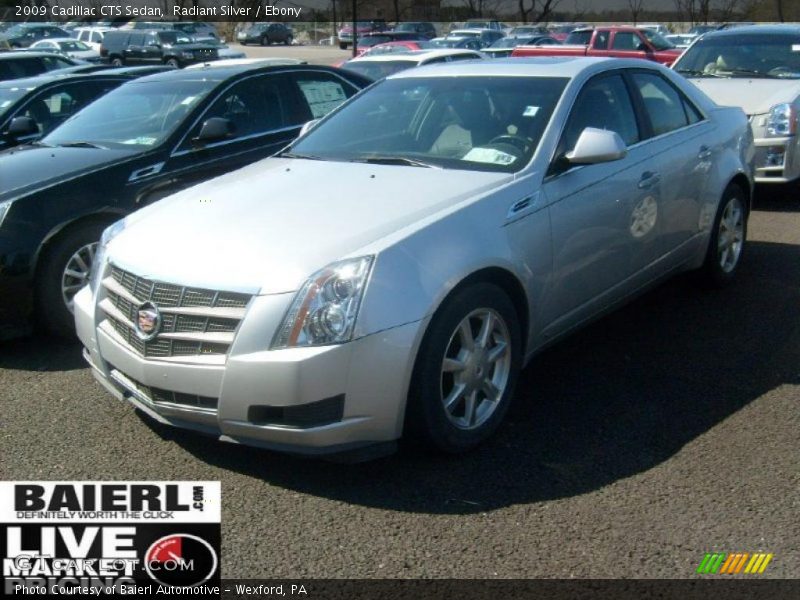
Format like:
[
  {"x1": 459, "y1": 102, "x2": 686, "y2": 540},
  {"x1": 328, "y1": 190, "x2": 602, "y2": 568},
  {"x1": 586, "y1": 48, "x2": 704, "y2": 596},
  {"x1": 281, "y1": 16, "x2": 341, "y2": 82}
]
[{"x1": 0, "y1": 67, "x2": 164, "y2": 150}]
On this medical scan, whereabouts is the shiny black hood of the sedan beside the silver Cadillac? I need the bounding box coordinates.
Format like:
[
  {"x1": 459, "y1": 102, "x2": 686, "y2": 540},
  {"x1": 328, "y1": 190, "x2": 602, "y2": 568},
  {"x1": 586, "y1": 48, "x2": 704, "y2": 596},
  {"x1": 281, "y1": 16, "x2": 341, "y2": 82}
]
[{"x1": 0, "y1": 146, "x2": 140, "y2": 202}]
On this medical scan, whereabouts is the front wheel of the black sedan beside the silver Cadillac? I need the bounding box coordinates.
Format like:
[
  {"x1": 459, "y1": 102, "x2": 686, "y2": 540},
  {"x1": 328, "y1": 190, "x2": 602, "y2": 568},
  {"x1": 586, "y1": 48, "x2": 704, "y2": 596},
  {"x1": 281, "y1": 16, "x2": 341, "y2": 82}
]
[{"x1": 36, "y1": 223, "x2": 106, "y2": 337}]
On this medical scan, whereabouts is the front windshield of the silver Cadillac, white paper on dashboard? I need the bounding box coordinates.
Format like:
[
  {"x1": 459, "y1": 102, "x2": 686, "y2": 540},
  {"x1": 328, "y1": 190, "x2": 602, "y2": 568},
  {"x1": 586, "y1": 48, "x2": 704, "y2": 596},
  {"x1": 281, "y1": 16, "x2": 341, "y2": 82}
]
[{"x1": 289, "y1": 77, "x2": 568, "y2": 173}]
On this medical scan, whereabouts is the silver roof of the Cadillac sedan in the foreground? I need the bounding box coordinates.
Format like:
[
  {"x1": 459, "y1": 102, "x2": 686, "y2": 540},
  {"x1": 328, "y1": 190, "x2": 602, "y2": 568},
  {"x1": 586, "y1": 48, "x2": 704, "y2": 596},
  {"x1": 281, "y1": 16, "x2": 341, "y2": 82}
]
[{"x1": 388, "y1": 56, "x2": 659, "y2": 79}]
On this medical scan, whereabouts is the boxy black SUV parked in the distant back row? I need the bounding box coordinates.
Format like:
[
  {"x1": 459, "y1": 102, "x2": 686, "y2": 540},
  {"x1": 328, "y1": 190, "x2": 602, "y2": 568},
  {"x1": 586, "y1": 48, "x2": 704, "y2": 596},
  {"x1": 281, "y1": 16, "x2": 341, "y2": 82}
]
[{"x1": 100, "y1": 29, "x2": 217, "y2": 67}]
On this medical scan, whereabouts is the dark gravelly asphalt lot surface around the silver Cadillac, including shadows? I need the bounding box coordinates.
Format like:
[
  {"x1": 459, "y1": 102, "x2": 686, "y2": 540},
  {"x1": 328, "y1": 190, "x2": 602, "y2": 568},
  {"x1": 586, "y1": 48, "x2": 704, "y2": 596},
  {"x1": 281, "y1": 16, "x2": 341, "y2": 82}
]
[{"x1": 0, "y1": 190, "x2": 800, "y2": 578}]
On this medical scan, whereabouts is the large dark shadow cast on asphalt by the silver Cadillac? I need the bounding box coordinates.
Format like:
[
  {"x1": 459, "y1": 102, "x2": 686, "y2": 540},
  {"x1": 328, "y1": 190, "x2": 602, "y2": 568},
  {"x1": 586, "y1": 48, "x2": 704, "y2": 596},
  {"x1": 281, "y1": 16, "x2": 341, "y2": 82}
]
[{"x1": 147, "y1": 242, "x2": 800, "y2": 513}]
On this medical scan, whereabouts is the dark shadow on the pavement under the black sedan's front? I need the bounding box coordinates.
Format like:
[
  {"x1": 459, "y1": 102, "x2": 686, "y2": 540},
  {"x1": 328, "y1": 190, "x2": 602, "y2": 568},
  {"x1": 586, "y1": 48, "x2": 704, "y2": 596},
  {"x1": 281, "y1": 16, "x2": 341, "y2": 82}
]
[{"x1": 0, "y1": 333, "x2": 86, "y2": 372}]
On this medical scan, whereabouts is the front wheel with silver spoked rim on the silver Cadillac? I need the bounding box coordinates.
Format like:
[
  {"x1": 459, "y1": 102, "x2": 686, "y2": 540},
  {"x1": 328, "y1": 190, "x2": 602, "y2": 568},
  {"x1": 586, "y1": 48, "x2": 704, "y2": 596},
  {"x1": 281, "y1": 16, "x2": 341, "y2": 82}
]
[{"x1": 405, "y1": 283, "x2": 522, "y2": 454}]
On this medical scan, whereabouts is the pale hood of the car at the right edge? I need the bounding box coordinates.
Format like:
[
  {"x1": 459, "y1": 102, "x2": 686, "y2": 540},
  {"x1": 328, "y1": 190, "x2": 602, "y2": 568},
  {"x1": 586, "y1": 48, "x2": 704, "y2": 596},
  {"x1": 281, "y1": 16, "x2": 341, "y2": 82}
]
[{"x1": 691, "y1": 77, "x2": 800, "y2": 115}]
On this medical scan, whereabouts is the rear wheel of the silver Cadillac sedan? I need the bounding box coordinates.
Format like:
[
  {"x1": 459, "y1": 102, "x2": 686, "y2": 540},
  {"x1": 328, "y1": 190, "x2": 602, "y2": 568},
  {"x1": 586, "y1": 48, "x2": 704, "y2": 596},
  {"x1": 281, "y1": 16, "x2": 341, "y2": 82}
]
[{"x1": 698, "y1": 183, "x2": 748, "y2": 287}]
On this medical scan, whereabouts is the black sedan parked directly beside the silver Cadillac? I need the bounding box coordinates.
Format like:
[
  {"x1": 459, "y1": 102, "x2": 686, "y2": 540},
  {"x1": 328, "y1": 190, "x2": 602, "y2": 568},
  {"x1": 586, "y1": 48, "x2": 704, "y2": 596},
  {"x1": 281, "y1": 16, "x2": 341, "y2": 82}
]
[{"x1": 0, "y1": 63, "x2": 370, "y2": 338}]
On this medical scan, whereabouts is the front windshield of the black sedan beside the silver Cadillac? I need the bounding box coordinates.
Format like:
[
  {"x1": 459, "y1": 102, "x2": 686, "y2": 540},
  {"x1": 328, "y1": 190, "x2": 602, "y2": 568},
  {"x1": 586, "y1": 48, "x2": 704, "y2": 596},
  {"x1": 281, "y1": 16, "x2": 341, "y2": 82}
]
[{"x1": 42, "y1": 81, "x2": 211, "y2": 150}]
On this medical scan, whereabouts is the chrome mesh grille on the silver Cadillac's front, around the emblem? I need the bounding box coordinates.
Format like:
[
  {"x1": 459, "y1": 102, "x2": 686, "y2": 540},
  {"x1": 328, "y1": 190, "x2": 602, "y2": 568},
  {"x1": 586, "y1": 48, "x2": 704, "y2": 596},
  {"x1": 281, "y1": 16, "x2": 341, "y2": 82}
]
[{"x1": 100, "y1": 266, "x2": 251, "y2": 360}]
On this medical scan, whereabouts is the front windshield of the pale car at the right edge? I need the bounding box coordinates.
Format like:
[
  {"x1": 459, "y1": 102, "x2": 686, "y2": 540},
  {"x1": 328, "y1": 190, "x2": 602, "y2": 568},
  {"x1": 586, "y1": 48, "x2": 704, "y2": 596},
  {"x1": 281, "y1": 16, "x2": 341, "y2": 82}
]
[{"x1": 673, "y1": 33, "x2": 800, "y2": 79}]
